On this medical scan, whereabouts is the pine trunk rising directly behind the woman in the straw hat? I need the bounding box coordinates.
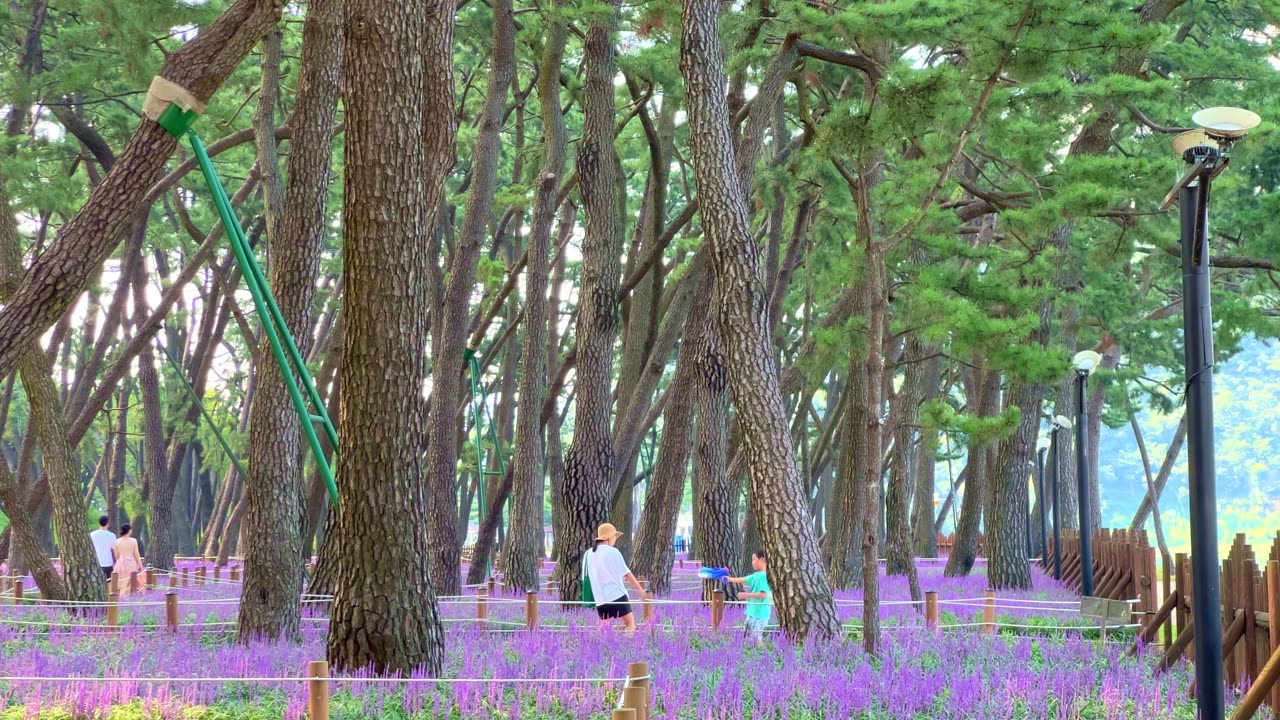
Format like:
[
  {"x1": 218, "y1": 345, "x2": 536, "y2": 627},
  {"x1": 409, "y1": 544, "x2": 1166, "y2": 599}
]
[{"x1": 556, "y1": 0, "x2": 623, "y2": 601}]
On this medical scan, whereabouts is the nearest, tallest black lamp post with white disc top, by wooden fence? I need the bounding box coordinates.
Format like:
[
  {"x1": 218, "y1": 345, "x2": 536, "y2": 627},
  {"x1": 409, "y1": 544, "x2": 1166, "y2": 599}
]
[{"x1": 1165, "y1": 108, "x2": 1262, "y2": 720}]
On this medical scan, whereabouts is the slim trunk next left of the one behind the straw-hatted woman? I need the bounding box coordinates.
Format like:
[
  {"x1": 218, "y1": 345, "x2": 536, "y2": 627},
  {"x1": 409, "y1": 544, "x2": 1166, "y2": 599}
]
[{"x1": 504, "y1": 4, "x2": 568, "y2": 591}]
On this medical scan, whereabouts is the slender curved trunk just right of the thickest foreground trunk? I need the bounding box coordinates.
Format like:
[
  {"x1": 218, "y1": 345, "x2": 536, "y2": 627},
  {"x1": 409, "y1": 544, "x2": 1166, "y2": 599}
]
[{"x1": 426, "y1": 0, "x2": 516, "y2": 594}]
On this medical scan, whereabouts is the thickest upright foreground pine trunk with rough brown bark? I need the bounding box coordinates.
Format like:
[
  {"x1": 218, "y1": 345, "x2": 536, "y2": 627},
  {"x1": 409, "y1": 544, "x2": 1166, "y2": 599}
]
[{"x1": 328, "y1": 0, "x2": 454, "y2": 674}]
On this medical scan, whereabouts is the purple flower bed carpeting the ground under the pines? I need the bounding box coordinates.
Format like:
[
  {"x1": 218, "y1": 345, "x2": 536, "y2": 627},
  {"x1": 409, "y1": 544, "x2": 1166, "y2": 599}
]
[{"x1": 0, "y1": 560, "x2": 1223, "y2": 720}]
